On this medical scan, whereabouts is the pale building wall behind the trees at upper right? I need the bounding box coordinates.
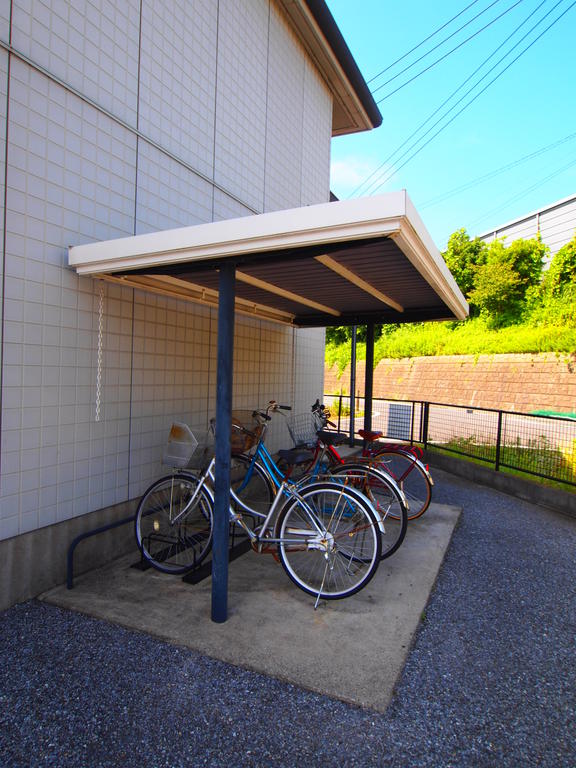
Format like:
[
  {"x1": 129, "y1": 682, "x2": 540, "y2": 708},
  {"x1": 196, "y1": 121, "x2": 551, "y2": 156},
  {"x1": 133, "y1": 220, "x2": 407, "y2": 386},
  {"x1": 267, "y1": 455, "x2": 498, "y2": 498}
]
[{"x1": 480, "y1": 196, "x2": 576, "y2": 258}]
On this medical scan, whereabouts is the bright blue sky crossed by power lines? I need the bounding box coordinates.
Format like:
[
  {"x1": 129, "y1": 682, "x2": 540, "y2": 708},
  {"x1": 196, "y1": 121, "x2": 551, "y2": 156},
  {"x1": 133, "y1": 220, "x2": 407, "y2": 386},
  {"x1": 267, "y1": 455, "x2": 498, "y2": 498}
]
[{"x1": 327, "y1": 0, "x2": 576, "y2": 250}]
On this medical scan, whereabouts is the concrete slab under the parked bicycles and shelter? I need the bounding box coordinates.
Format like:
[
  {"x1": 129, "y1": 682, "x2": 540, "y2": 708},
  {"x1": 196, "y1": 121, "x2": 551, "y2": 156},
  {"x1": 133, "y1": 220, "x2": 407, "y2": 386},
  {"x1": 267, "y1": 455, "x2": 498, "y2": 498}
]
[{"x1": 40, "y1": 504, "x2": 460, "y2": 712}]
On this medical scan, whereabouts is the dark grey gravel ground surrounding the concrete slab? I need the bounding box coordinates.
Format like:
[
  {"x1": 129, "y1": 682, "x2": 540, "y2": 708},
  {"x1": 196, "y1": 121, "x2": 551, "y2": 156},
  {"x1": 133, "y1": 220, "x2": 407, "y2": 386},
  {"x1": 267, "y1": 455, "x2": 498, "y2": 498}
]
[{"x1": 0, "y1": 471, "x2": 576, "y2": 768}]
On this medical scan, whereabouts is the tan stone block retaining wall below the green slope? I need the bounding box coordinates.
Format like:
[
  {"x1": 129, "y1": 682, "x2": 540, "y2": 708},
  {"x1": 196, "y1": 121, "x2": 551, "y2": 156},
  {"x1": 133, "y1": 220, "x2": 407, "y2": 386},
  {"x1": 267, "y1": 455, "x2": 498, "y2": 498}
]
[{"x1": 324, "y1": 353, "x2": 576, "y2": 413}]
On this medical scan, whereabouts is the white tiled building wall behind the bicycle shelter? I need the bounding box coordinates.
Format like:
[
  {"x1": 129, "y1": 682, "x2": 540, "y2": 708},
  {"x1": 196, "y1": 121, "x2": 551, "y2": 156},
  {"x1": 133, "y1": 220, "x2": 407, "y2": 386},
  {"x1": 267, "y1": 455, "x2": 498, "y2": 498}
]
[{"x1": 0, "y1": 0, "x2": 332, "y2": 606}]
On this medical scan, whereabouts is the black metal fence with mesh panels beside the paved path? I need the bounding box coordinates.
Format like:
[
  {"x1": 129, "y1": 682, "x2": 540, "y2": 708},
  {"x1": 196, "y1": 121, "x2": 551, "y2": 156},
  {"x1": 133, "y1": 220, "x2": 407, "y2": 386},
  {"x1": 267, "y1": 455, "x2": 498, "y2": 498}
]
[{"x1": 324, "y1": 395, "x2": 576, "y2": 486}]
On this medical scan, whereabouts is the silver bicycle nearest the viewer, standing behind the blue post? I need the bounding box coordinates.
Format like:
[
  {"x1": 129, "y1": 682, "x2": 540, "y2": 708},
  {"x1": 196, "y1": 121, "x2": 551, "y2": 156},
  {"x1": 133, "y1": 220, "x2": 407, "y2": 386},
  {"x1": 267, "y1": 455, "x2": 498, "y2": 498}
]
[{"x1": 135, "y1": 414, "x2": 382, "y2": 608}]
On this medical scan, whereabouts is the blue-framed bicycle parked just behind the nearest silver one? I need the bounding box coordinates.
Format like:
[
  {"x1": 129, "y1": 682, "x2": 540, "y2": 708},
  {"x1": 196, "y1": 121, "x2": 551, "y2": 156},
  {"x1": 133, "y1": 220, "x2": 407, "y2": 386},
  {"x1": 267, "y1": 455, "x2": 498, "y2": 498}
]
[{"x1": 233, "y1": 400, "x2": 408, "y2": 559}]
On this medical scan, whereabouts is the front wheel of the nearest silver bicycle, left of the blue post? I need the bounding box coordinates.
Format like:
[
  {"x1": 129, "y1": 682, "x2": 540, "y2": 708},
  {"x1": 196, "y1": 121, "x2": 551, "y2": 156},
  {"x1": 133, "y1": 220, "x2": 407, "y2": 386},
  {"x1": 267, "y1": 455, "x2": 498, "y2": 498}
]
[{"x1": 136, "y1": 473, "x2": 214, "y2": 574}]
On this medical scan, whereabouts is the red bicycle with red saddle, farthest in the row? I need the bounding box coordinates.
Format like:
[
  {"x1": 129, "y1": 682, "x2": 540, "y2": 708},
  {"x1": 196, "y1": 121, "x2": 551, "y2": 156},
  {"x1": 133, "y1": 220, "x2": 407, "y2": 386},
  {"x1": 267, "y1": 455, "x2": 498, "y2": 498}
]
[{"x1": 289, "y1": 400, "x2": 434, "y2": 521}]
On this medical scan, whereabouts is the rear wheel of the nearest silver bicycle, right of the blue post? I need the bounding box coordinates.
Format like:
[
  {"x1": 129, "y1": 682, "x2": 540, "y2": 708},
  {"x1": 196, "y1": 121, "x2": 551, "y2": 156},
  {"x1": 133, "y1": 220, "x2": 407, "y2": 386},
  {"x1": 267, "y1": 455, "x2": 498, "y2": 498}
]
[{"x1": 276, "y1": 482, "x2": 381, "y2": 600}]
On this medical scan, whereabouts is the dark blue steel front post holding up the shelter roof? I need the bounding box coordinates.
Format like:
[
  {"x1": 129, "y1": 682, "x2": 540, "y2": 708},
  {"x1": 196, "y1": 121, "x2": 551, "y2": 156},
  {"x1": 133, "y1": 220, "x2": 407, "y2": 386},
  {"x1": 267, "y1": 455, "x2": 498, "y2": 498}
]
[{"x1": 212, "y1": 264, "x2": 236, "y2": 624}]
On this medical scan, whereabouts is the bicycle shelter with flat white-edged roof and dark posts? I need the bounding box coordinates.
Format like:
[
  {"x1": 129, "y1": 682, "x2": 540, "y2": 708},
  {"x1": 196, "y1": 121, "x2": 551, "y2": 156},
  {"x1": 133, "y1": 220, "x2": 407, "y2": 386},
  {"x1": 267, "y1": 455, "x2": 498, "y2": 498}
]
[{"x1": 69, "y1": 191, "x2": 468, "y2": 622}]
